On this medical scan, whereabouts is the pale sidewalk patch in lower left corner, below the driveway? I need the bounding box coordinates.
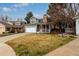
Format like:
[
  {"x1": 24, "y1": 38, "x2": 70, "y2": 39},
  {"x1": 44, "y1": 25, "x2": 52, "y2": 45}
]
[{"x1": 0, "y1": 44, "x2": 16, "y2": 56}]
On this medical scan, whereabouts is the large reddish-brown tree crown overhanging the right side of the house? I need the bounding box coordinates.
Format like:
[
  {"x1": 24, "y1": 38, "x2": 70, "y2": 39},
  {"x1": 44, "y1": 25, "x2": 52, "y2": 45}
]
[{"x1": 47, "y1": 3, "x2": 79, "y2": 34}]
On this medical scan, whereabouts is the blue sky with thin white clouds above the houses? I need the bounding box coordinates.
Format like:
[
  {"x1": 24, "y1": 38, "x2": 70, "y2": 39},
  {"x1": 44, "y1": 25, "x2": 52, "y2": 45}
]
[{"x1": 0, "y1": 3, "x2": 48, "y2": 20}]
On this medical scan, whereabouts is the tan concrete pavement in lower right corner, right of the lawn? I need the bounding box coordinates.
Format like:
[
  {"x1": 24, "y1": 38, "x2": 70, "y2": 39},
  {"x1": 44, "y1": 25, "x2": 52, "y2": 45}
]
[{"x1": 46, "y1": 38, "x2": 79, "y2": 56}]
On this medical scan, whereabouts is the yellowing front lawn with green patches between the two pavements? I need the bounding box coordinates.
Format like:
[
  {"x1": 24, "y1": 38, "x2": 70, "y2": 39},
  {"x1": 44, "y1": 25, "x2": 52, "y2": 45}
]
[{"x1": 6, "y1": 34, "x2": 75, "y2": 56}]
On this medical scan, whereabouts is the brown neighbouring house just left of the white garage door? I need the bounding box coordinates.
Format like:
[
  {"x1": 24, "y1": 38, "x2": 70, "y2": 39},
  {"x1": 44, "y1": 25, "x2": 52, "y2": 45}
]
[{"x1": 10, "y1": 21, "x2": 26, "y2": 33}]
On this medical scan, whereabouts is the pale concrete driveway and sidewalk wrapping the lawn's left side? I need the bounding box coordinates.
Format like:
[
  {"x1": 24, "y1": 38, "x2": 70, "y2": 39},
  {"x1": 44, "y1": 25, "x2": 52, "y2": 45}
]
[{"x1": 0, "y1": 33, "x2": 26, "y2": 56}]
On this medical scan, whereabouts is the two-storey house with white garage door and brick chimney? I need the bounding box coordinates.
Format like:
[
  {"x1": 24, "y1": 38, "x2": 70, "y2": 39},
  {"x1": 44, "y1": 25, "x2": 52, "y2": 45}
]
[{"x1": 25, "y1": 16, "x2": 51, "y2": 33}]
